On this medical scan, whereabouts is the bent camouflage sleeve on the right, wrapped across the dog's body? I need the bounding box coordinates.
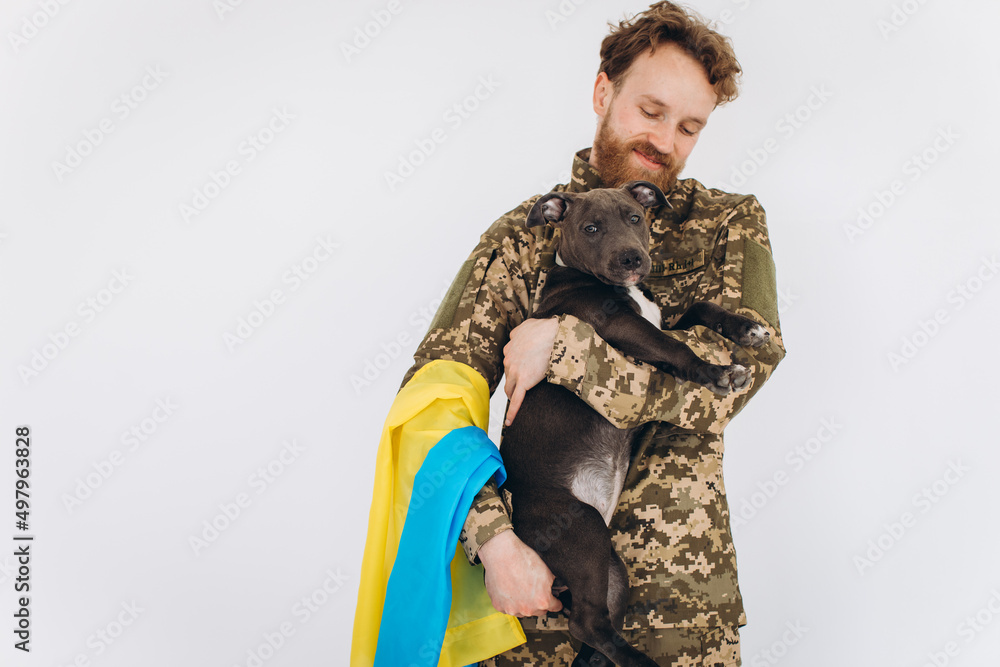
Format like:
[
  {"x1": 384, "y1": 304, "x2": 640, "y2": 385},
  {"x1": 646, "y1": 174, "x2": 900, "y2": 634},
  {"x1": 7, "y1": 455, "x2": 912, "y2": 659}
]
[{"x1": 546, "y1": 196, "x2": 785, "y2": 433}]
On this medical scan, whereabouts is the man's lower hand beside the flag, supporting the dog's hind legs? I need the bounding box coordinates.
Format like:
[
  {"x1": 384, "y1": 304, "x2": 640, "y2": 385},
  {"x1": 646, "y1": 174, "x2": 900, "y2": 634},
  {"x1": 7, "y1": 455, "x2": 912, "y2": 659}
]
[{"x1": 479, "y1": 530, "x2": 562, "y2": 616}]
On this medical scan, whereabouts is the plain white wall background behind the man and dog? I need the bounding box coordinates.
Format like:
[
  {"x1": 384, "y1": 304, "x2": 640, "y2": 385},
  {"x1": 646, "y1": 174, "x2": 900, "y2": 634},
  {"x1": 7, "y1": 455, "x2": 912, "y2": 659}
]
[{"x1": 0, "y1": 0, "x2": 1000, "y2": 667}]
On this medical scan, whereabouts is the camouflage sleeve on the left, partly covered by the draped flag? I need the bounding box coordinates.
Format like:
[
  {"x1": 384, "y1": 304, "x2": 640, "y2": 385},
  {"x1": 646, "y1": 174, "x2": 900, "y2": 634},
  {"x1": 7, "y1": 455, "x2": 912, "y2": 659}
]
[{"x1": 403, "y1": 207, "x2": 537, "y2": 565}]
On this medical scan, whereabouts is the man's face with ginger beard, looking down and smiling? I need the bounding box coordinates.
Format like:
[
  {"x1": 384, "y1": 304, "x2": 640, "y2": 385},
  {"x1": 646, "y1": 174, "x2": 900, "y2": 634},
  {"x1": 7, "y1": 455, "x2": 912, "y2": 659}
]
[{"x1": 590, "y1": 44, "x2": 717, "y2": 192}]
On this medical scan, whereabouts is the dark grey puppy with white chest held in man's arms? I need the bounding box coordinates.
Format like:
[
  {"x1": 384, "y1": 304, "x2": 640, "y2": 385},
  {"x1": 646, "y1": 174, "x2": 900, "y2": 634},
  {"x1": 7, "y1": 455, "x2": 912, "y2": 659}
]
[{"x1": 501, "y1": 181, "x2": 769, "y2": 667}]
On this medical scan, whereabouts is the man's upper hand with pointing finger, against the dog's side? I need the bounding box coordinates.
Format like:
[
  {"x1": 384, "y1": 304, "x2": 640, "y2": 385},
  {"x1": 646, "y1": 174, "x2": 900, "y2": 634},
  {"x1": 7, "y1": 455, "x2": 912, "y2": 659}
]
[{"x1": 503, "y1": 317, "x2": 559, "y2": 426}]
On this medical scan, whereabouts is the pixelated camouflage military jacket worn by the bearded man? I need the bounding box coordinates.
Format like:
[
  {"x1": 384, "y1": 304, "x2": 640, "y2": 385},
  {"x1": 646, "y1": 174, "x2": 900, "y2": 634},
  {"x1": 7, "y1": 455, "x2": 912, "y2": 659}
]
[{"x1": 403, "y1": 149, "x2": 785, "y2": 630}]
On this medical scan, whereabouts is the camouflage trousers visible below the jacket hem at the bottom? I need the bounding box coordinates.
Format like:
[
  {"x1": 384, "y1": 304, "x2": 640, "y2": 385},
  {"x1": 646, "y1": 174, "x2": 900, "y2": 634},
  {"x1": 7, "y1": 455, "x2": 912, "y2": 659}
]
[{"x1": 479, "y1": 627, "x2": 742, "y2": 667}]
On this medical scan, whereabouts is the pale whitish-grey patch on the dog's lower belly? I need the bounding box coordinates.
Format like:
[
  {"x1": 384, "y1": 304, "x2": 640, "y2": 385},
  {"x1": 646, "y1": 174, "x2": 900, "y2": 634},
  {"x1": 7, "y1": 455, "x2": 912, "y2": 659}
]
[{"x1": 569, "y1": 427, "x2": 632, "y2": 524}]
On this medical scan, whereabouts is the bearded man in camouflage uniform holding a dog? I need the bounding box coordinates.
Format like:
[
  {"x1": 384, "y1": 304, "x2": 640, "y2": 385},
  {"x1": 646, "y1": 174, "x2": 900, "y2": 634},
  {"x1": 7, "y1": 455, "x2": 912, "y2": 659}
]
[{"x1": 403, "y1": 2, "x2": 784, "y2": 667}]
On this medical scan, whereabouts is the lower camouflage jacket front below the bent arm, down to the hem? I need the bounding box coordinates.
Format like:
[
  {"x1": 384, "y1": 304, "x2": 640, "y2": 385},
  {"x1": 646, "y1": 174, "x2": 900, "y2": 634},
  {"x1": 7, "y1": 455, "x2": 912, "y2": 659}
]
[{"x1": 611, "y1": 428, "x2": 746, "y2": 631}]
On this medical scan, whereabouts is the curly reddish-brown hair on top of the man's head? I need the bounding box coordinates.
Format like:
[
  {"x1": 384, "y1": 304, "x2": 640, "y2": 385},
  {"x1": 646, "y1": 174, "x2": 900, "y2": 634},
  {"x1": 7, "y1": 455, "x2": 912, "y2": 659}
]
[{"x1": 598, "y1": 2, "x2": 743, "y2": 105}]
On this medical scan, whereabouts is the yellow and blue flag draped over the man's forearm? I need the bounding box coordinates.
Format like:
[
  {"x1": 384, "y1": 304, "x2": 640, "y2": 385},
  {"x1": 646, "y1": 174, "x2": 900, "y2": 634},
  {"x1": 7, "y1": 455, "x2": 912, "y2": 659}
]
[{"x1": 351, "y1": 360, "x2": 525, "y2": 667}]
